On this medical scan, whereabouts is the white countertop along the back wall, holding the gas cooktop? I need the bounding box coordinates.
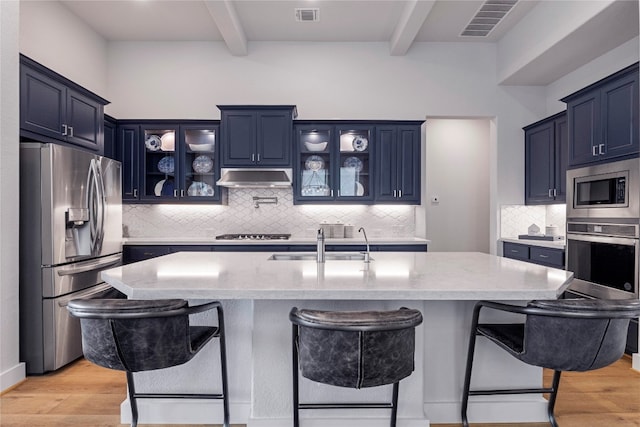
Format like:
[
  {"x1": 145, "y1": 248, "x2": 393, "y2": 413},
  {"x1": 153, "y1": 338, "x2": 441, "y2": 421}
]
[{"x1": 122, "y1": 236, "x2": 431, "y2": 245}]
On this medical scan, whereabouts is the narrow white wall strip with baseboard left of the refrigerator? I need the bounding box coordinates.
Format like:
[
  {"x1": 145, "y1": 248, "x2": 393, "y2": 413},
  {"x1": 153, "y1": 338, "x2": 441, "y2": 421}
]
[{"x1": 0, "y1": 1, "x2": 25, "y2": 391}]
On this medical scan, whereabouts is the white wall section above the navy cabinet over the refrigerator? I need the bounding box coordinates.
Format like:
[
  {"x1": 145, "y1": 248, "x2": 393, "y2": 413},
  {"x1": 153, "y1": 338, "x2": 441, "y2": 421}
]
[{"x1": 19, "y1": 1, "x2": 109, "y2": 99}]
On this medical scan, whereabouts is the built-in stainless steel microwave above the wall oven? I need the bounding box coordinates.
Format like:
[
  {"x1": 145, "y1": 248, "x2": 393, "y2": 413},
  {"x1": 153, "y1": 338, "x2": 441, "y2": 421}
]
[{"x1": 567, "y1": 158, "x2": 640, "y2": 219}]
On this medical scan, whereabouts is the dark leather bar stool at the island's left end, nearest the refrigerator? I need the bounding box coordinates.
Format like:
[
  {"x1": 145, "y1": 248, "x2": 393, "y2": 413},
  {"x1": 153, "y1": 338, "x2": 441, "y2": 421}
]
[{"x1": 67, "y1": 299, "x2": 229, "y2": 427}]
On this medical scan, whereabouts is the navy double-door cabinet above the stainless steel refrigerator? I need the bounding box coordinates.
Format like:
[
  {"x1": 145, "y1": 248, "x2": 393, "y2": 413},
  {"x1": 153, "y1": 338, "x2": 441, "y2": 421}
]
[{"x1": 20, "y1": 55, "x2": 109, "y2": 154}]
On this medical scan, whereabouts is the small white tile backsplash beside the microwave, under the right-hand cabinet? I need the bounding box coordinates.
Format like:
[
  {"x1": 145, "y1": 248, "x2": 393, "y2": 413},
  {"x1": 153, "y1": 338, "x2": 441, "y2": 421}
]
[{"x1": 500, "y1": 204, "x2": 567, "y2": 238}]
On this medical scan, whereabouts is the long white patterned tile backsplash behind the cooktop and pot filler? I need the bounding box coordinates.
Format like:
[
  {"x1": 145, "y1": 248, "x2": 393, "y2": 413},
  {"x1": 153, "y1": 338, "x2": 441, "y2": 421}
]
[{"x1": 122, "y1": 189, "x2": 415, "y2": 238}]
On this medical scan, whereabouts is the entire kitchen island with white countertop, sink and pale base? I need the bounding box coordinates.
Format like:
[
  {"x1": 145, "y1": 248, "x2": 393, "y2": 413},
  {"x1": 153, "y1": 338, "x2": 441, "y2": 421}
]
[{"x1": 103, "y1": 252, "x2": 572, "y2": 427}]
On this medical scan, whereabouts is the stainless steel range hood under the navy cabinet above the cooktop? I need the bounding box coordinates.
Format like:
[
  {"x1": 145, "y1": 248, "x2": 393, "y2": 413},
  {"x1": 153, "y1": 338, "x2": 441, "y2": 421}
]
[{"x1": 216, "y1": 168, "x2": 292, "y2": 188}]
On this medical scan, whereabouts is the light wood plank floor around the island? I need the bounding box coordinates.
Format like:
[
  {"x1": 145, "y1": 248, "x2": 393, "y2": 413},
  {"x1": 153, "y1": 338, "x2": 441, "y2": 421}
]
[{"x1": 0, "y1": 356, "x2": 640, "y2": 427}]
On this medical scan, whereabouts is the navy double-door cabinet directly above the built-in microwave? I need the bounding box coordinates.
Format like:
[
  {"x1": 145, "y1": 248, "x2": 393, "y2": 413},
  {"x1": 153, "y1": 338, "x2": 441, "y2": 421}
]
[{"x1": 562, "y1": 63, "x2": 640, "y2": 168}]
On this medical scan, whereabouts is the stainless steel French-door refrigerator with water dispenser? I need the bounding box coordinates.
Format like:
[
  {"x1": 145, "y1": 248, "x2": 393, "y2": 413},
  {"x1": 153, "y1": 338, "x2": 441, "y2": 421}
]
[{"x1": 19, "y1": 142, "x2": 122, "y2": 374}]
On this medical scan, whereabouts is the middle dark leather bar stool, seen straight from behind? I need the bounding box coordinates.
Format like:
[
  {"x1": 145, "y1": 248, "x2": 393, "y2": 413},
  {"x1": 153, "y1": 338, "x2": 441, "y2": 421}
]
[{"x1": 289, "y1": 307, "x2": 422, "y2": 427}]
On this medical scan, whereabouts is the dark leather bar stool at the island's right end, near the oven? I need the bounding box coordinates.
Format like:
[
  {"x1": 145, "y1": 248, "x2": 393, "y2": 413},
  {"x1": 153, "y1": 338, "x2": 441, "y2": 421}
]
[{"x1": 461, "y1": 299, "x2": 640, "y2": 427}]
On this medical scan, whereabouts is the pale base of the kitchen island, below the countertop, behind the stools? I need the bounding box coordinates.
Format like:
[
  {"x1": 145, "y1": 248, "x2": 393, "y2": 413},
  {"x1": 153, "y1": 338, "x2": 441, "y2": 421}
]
[{"x1": 121, "y1": 300, "x2": 547, "y2": 427}]
